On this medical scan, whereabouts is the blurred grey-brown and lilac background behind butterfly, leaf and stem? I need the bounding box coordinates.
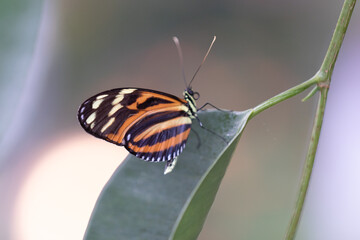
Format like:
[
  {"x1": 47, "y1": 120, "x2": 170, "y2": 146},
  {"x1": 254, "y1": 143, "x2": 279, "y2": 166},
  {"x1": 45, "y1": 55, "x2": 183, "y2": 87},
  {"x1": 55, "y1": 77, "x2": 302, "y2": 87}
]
[{"x1": 0, "y1": 0, "x2": 360, "y2": 240}]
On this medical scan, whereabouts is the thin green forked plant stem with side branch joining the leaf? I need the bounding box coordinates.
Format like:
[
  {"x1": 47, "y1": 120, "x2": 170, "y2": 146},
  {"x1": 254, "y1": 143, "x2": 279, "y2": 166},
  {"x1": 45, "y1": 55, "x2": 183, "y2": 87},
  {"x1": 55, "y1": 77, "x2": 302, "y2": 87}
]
[{"x1": 249, "y1": 0, "x2": 356, "y2": 240}]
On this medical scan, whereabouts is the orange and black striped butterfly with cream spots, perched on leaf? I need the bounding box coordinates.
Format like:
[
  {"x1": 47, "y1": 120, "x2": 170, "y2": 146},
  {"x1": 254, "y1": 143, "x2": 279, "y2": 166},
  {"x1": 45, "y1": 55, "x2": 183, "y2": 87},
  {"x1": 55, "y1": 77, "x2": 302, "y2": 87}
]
[{"x1": 78, "y1": 37, "x2": 222, "y2": 174}]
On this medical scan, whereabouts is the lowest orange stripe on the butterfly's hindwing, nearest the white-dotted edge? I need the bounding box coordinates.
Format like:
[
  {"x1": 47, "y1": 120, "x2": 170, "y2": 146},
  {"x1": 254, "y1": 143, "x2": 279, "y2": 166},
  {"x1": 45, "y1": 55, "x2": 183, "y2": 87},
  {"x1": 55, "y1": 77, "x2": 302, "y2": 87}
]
[{"x1": 128, "y1": 128, "x2": 190, "y2": 153}]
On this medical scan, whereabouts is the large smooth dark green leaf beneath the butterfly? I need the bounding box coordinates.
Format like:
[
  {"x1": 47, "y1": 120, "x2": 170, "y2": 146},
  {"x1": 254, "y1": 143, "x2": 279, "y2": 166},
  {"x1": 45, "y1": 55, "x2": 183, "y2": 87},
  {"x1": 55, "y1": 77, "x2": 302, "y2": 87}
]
[{"x1": 85, "y1": 110, "x2": 252, "y2": 240}]
